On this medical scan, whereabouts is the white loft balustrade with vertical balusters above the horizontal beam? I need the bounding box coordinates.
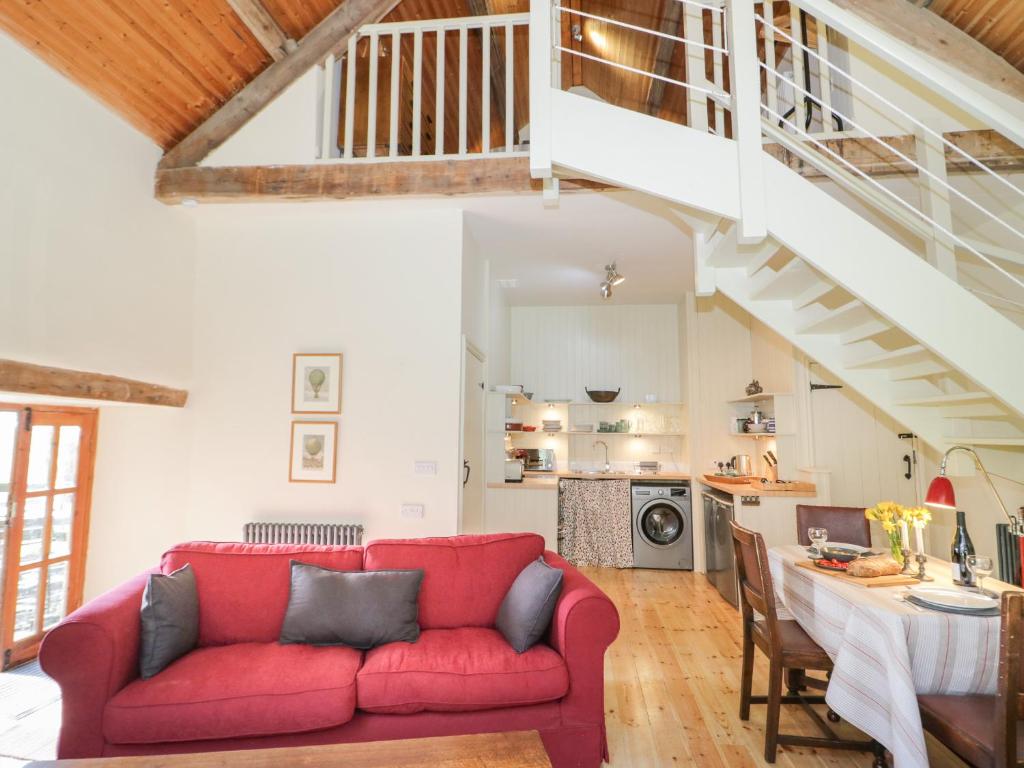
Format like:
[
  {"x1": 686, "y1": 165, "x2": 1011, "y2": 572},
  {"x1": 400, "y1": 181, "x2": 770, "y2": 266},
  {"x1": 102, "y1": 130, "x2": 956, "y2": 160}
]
[{"x1": 317, "y1": 13, "x2": 529, "y2": 162}]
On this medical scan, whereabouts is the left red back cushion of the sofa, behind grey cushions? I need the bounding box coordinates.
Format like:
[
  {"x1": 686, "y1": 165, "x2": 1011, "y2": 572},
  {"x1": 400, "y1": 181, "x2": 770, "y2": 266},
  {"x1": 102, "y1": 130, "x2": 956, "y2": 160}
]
[{"x1": 160, "y1": 542, "x2": 362, "y2": 647}]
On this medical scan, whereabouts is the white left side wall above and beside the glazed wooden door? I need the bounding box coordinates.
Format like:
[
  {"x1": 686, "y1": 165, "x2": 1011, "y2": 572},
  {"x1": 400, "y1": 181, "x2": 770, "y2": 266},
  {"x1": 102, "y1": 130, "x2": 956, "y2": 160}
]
[{"x1": 0, "y1": 35, "x2": 195, "y2": 597}]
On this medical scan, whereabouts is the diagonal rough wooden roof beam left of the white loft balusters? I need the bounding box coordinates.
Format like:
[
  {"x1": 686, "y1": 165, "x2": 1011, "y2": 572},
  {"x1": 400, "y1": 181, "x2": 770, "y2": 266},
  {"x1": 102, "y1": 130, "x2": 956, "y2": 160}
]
[{"x1": 160, "y1": 0, "x2": 398, "y2": 168}]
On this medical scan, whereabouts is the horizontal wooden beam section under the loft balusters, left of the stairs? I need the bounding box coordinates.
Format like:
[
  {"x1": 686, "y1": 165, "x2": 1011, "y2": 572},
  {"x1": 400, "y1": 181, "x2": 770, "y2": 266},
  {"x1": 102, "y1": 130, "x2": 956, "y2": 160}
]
[{"x1": 156, "y1": 157, "x2": 610, "y2": 205}]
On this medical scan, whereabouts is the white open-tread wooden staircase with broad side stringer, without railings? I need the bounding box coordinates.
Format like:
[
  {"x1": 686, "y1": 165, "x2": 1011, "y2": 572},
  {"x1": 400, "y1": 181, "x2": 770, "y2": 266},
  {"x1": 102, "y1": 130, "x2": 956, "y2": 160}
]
[{"x1": 531, "y1": 0, "x2": 1024, "y2": 450}]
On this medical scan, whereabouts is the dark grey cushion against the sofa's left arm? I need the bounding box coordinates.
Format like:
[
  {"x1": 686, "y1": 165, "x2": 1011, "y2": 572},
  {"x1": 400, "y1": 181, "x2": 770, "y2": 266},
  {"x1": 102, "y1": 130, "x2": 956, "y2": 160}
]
[{"x1": 138, "y1": 563, "x2": 199, "y2": 680}]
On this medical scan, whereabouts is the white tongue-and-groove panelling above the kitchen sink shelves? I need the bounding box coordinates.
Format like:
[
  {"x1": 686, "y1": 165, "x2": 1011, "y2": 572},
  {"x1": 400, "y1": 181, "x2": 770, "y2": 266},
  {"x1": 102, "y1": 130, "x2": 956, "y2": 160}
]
[{"x1": 509, "y1": 305, "x2": 681, "y2": 402}]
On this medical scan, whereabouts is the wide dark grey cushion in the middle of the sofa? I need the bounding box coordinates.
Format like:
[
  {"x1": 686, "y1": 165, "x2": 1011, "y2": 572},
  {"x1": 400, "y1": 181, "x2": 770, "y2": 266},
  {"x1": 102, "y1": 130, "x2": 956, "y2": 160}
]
[{"x1": 281, "y1": 560, "x2": 423, "y2": 650}]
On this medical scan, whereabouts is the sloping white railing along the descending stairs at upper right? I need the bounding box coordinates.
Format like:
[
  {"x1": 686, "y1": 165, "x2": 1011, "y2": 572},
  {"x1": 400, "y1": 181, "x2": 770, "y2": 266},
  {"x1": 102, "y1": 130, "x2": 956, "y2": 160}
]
[{"x1": 755, "y1": 4, "x2": 1024, "y2": 308}]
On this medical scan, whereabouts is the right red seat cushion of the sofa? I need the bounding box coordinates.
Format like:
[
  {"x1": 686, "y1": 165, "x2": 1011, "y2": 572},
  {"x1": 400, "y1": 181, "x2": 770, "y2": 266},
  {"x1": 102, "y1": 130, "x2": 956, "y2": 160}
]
[{"x1": 356, "y1": 627, "x2": 569, "y2": 715}]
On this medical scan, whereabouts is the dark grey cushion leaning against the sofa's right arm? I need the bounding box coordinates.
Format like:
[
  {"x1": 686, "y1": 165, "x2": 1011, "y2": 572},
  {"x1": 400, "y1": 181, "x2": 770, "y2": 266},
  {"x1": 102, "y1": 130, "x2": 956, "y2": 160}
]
[{"x1": 496, "y1": 557, "x2": 562, "y2": 653}]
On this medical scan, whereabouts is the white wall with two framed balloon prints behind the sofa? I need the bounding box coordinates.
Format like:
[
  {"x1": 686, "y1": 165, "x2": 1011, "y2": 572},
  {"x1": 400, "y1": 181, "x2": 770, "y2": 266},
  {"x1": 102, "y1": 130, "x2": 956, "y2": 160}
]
[{"x1": 187, "y1": 204, "x2": 462, "y2": 539}]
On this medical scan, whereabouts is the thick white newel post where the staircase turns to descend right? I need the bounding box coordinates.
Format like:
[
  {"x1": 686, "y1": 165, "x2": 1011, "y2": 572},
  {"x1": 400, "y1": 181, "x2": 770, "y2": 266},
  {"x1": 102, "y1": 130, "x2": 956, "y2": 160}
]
[{"x1": 726, "y1": 0, "x2": 768, "y2": 244}]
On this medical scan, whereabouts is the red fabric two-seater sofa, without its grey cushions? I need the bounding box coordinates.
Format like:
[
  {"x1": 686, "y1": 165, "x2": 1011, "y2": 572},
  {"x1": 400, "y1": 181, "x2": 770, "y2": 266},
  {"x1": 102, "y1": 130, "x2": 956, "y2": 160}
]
[{"x1": 40, "y1": 534, "x2": 618, "y2": 768}]
